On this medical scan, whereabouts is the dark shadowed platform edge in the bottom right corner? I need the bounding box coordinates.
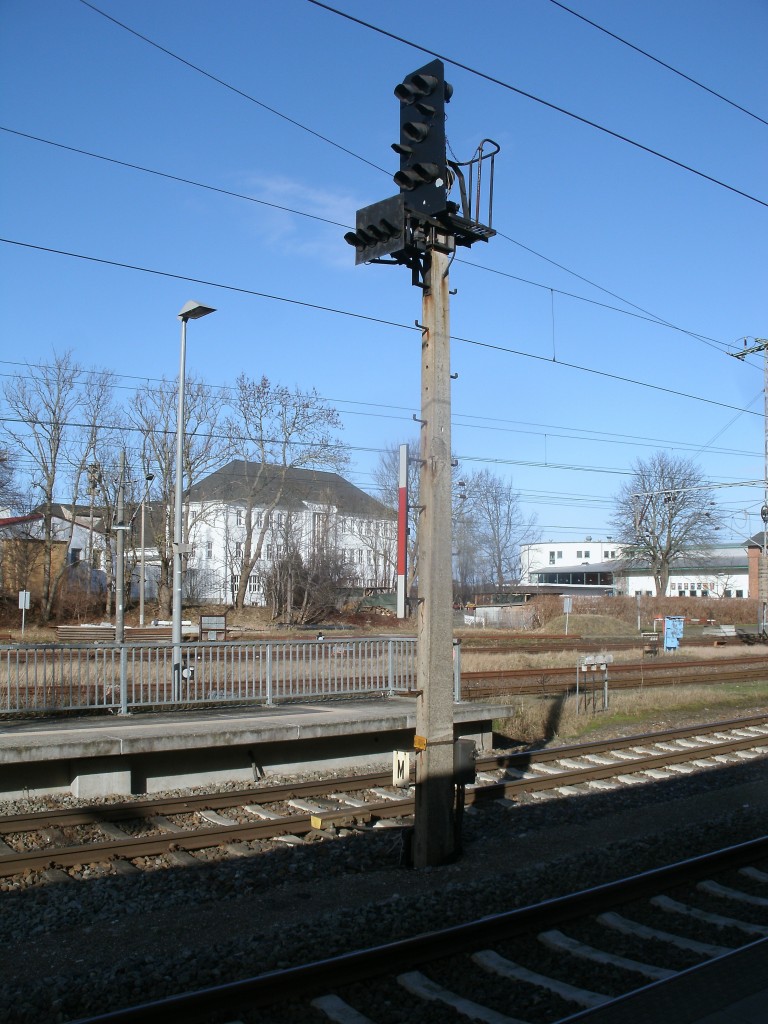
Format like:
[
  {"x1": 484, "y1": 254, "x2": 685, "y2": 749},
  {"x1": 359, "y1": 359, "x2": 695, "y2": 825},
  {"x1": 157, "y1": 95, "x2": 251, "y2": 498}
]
[{"x1": 563, "y1": 939, "x2": 768, "y2": 1024}]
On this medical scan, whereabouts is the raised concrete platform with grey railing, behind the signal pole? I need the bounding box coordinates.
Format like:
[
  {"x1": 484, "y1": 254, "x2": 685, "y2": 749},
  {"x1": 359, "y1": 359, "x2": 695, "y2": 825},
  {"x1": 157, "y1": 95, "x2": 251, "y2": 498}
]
[{"x1": 0, "y1": 696, "x2": 510, "y2": 800}]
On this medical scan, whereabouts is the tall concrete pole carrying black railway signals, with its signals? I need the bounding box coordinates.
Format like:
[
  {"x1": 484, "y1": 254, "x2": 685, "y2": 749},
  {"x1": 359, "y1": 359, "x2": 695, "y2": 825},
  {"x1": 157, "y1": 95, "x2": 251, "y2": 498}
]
[{"x1": 344, "y1": 60, "x2": 499, "y2": 867}]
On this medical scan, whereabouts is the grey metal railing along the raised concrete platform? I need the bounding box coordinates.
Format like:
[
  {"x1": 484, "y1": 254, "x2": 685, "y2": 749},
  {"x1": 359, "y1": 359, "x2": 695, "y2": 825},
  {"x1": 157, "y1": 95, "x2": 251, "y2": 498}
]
[{"x1": 0, "y1": 637, "x2": 416, "y2": 714}]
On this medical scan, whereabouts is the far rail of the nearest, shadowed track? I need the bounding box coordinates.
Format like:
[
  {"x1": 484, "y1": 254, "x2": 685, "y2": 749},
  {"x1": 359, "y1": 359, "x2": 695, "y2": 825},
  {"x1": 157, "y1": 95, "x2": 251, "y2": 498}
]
[{"x1": 66, "y1": 837, "x2": 768, "y2": 1024}]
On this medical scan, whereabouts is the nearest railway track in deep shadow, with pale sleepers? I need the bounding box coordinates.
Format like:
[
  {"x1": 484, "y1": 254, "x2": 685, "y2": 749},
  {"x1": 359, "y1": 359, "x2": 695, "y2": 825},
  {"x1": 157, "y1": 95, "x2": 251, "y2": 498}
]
[{"x1": 69, "y1": 837, "x2": 768, "y2": 1024}]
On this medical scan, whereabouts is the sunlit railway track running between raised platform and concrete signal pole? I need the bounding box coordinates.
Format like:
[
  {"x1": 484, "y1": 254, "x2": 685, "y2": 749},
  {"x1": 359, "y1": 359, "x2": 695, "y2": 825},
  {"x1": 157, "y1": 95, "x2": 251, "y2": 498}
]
[{"x1": 0, "y1": 716, "x2": 768, "y2": 882}]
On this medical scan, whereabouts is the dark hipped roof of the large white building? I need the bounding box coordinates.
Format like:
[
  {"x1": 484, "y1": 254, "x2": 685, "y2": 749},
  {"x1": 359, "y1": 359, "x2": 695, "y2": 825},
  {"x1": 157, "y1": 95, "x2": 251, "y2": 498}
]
[{"x1": 189, "y1": 459, "x2": 395, "y2": 519}]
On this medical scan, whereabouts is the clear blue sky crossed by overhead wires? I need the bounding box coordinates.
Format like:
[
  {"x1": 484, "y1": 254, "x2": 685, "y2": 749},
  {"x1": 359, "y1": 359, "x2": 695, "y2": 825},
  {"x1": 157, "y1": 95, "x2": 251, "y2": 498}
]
[{"x1": 0, "y1": 0, "x2": 768, "y2": 540}]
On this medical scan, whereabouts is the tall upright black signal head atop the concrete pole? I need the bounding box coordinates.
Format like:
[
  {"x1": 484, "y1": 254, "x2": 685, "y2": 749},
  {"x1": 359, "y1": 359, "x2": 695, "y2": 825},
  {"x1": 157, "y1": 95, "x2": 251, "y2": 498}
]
[{"x1": 392, "y1": 60, "x2": 453, "y2": 216}]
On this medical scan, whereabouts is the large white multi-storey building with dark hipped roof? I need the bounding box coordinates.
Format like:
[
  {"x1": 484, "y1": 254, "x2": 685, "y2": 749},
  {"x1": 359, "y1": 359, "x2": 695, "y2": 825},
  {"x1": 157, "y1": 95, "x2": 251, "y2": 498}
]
[{"x1": 185, "y1": 460, "x2": 396, "y2": 604}]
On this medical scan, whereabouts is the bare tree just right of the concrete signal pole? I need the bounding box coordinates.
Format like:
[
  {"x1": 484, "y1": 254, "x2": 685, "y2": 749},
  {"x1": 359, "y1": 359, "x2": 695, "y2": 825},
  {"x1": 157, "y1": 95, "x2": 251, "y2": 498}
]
[{"x1": 462, "y1": 469, "x2": 537, "y2": 587}]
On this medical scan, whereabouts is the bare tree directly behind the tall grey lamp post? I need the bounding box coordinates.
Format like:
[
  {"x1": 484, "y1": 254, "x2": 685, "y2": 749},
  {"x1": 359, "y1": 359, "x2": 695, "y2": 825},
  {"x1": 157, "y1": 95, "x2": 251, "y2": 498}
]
[{"x1": 129, "y1": 377, "x2": 230, "y2": 618}]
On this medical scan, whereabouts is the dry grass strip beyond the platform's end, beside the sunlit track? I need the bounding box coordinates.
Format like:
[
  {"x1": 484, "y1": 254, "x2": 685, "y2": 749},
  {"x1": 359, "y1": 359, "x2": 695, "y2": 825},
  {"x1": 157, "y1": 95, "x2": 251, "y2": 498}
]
[{"x1": 494, "y1": 681, "x2": 768, "y2": 745}]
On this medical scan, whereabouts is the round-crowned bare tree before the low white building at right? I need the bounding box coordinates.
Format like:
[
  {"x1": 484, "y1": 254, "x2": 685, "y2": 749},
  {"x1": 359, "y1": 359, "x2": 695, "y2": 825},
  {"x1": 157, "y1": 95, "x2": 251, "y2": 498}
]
[{"x1": 611, "y1": 452, "x2": 720, "y2": 597}]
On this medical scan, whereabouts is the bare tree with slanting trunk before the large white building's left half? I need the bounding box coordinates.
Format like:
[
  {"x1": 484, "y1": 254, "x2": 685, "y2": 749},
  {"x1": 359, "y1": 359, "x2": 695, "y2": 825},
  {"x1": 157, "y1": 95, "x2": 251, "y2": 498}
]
[{"x1": 228, "y1": 374, "x2": 348, "y2": 608}]
